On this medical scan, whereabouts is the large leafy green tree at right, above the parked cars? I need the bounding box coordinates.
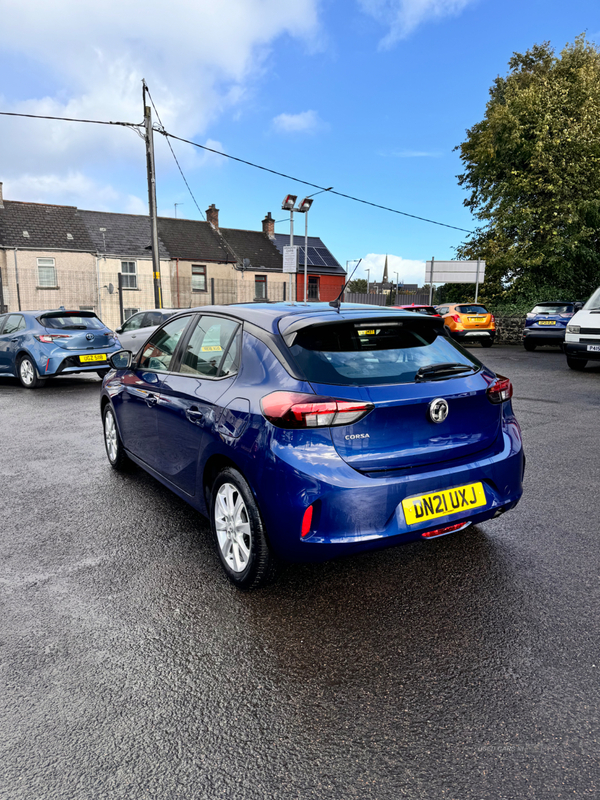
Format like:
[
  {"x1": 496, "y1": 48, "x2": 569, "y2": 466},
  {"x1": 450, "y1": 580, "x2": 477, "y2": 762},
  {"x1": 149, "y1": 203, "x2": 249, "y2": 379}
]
[{"x1": 456, "y1": 35, "x2": 600, "y2": 302}]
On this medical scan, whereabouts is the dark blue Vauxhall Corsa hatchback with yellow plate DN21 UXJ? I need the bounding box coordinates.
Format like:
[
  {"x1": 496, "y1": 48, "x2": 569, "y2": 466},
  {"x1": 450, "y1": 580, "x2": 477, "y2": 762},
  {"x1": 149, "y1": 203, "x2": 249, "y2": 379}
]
[{"x1": 101, "y1": 303, "x2": 525, "y2": 589}]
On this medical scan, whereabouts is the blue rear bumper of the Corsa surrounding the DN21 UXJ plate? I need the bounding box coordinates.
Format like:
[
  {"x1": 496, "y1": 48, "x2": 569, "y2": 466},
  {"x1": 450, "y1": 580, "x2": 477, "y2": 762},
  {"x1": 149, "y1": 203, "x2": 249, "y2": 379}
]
[{"x1": 256, "y1": 409, "x2": 525, "y2": 561}]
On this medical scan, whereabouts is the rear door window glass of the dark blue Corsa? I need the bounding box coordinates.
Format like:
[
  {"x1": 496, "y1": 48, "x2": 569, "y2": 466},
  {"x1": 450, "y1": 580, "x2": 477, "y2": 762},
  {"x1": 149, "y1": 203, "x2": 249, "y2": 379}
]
[{"x1": 180, "y1": 316, "x2": 239, "y2": 378}]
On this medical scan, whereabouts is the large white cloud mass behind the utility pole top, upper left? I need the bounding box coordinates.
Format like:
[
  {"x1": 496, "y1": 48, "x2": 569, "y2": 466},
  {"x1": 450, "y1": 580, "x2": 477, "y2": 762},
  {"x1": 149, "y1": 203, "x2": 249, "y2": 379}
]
[{"x1": 0, "y1": 0, "x2": 319, "y2": 207}]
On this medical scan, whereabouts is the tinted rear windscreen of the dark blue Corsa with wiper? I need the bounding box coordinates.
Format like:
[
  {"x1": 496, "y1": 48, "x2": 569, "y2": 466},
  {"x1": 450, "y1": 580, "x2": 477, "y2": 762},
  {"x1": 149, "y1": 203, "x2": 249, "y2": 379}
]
[{"x1": 290, "y1": 322, "x2": 480, "y2": 386}]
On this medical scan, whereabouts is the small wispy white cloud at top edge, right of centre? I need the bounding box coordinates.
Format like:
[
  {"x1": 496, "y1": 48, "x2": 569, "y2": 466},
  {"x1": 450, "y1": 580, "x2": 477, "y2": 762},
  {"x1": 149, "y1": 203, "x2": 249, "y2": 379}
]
[{"x1": 358, "y1": 0, "x2": 475, "y2": 49}]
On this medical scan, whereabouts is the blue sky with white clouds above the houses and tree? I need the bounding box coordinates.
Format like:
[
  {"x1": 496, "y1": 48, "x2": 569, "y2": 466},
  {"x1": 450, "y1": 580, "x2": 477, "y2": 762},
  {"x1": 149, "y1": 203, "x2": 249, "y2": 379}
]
[{"x1": 0, "y1": 0, "x2": 600, "y2": 282}]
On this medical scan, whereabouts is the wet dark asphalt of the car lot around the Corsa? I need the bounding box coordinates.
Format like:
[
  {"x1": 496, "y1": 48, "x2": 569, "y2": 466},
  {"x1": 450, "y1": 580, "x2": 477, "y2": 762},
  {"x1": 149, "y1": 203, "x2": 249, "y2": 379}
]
[{"x1": 0, "y1": 347, "x2": 600, "y2": 800}]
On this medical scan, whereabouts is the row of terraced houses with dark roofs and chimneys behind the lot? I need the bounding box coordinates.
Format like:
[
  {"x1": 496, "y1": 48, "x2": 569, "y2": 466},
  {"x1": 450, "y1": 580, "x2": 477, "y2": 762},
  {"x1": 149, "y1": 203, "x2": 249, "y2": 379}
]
[{"x1": 0, "y1": 183, "x2": 345, "y2": 328}]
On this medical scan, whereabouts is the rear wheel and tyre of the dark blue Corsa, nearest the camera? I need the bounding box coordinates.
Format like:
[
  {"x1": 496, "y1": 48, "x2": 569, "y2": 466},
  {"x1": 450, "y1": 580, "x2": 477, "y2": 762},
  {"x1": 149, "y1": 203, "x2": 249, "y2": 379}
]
[{"x1": 210, "y1": 467, "x2": 277, "y2": 591}]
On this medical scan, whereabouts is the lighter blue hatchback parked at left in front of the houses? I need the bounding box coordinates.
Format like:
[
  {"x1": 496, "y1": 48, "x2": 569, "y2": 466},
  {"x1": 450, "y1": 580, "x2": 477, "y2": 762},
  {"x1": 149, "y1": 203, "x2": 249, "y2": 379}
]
[{"x1": 0, "y1": 308, "x2": 121, "y2": 389}]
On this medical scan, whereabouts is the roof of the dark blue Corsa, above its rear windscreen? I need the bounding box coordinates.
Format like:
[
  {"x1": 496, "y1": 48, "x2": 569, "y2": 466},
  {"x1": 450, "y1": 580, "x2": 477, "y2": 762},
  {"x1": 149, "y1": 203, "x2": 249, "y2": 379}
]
[{"x1": 180, "y1": 302, "x2": 424, "y2": 333}]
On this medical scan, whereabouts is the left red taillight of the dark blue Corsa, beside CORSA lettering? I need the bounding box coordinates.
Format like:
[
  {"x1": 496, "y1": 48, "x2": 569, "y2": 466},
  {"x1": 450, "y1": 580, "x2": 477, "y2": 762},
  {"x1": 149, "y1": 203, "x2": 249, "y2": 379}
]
[{"x1": 260, "y1": 392, "x2": 373, "y2": 428}]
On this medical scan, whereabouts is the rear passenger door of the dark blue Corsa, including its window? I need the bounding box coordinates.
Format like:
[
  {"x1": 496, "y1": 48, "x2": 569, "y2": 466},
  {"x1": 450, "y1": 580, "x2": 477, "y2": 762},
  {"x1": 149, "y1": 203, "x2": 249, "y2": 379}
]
[{"x1": 157, "y1": 315, "x2": 240, "y2": 496}]
